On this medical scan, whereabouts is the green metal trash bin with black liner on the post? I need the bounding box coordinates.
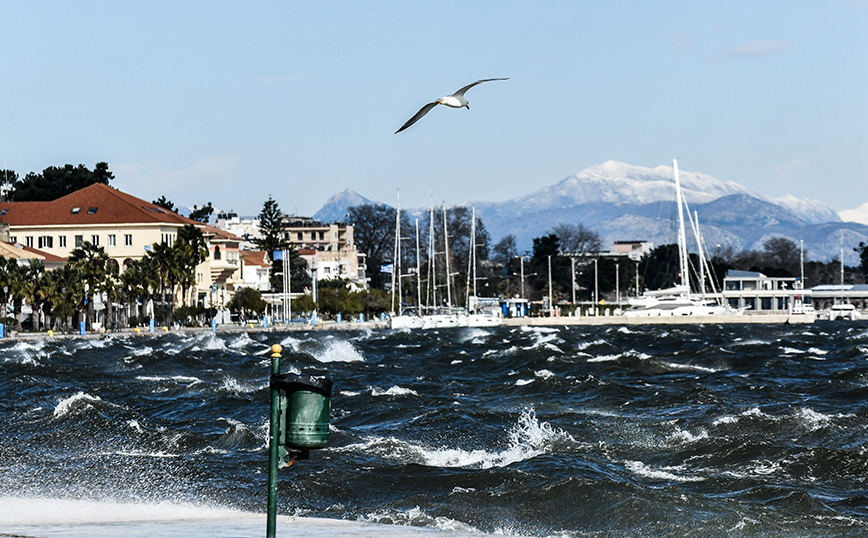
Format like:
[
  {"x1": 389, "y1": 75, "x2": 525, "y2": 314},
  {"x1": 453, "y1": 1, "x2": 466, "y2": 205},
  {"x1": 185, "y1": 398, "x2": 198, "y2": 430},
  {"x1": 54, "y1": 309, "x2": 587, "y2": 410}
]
[{"x1": 271, "y1": 374, "x2": 332, "y2": 451}]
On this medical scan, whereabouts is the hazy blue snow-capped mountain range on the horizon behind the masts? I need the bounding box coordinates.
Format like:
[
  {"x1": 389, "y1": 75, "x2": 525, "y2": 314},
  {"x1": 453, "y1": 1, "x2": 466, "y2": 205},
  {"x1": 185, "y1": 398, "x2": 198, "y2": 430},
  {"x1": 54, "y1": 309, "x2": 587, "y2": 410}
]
[{"x1": 315, "y1": 161, "x2": 868, "y2": 265}]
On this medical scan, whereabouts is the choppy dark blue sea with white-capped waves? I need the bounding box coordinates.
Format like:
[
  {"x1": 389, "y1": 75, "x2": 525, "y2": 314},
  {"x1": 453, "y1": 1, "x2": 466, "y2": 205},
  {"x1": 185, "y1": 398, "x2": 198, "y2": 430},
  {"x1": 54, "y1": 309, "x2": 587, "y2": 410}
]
[{"x1": 0, "y1": 322, "x2": 868, "y2": 537}]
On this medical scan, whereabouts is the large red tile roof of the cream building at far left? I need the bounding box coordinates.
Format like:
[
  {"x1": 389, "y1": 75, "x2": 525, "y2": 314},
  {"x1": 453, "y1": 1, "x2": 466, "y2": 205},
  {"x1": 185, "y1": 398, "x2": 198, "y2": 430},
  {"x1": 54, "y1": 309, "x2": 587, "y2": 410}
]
[{"x1": 0, "y1": 183, "x2": 202, "y2": 227}]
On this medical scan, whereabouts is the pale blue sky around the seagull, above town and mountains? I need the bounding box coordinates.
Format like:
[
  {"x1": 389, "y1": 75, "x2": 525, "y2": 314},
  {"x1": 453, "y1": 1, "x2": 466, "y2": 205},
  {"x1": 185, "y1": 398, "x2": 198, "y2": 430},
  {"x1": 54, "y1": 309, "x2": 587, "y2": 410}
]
[{"x1": 0, "y1": 0, "x2": 868, "y2": 215}]
